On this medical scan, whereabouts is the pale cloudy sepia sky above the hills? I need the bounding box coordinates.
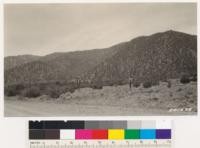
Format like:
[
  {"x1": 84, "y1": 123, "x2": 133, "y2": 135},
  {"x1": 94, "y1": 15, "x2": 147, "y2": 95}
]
[{"x1": 4, "y1": 3, "x2": 197, "y2": 56}]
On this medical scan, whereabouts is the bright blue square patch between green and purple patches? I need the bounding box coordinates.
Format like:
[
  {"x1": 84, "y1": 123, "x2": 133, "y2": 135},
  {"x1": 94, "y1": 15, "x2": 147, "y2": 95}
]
[{"x1": 140, "y1": 129, "x2": 156, "y2": 139}]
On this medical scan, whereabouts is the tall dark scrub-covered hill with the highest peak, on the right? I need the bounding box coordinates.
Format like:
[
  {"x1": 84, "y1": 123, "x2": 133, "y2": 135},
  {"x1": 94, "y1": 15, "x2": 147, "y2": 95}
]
[{"x1": 86, "y1": 31, "x2": 197, "y2": 83}]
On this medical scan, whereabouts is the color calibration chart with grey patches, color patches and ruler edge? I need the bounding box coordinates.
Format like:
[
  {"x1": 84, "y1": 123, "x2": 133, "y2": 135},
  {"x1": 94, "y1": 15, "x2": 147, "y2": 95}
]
[{"x1": 28, "y1": 120, "x2": 172, "y2": 148}]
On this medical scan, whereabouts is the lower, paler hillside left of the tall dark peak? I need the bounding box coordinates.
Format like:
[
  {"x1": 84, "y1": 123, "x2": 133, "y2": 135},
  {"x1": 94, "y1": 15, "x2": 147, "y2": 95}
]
[{"x1": 5, "y1": 49, "x2": 115, "y2": 85}]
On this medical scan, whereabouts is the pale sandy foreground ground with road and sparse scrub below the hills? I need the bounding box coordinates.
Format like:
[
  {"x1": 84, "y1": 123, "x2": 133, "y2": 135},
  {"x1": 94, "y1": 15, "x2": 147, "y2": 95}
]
[{"x1": 4, "y1": 80, "x2": 197, "y2": 117}]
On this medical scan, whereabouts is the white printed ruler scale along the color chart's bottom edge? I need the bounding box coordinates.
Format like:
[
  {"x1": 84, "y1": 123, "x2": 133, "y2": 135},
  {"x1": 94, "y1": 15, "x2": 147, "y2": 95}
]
[{"x1": 30, "y1": 140, "x2": 171, "y2": 148}]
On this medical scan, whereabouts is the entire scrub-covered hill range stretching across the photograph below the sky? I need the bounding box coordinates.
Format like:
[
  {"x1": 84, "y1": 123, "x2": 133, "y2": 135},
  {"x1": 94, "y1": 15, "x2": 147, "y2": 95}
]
[{"x1": 5, "y1": 31, "x2": 197, "y2": 85}]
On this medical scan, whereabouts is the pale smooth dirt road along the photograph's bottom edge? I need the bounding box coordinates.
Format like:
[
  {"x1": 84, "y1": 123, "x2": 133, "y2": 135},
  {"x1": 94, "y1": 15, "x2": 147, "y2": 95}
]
[{"x1": 5, "y1": 100, "x2": 195, "y2": 117}]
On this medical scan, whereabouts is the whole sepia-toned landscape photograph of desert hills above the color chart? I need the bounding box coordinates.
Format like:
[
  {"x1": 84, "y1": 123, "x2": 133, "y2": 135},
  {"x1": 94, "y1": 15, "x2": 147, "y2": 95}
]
[{"x1": 4, "y1": 2, "x2": 197, "y2": 117}]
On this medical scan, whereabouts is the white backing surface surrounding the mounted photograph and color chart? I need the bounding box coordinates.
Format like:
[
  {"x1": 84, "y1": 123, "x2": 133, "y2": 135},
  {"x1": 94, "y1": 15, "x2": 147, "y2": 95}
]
[{"x1": 0, "y1": 0, "x2": 200, "y2": 148}]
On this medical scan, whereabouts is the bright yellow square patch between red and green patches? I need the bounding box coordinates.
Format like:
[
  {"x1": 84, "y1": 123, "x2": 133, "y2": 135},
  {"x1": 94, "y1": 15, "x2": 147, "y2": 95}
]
[{"x1": 108, "y1": 129, "x2": 124, "y2": 140}]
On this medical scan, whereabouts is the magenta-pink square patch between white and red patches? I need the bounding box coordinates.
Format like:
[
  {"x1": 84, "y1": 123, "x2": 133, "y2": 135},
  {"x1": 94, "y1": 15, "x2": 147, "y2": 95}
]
[{"x1": 75, "y1": 129, "x2": 92, "y2": 139}]
